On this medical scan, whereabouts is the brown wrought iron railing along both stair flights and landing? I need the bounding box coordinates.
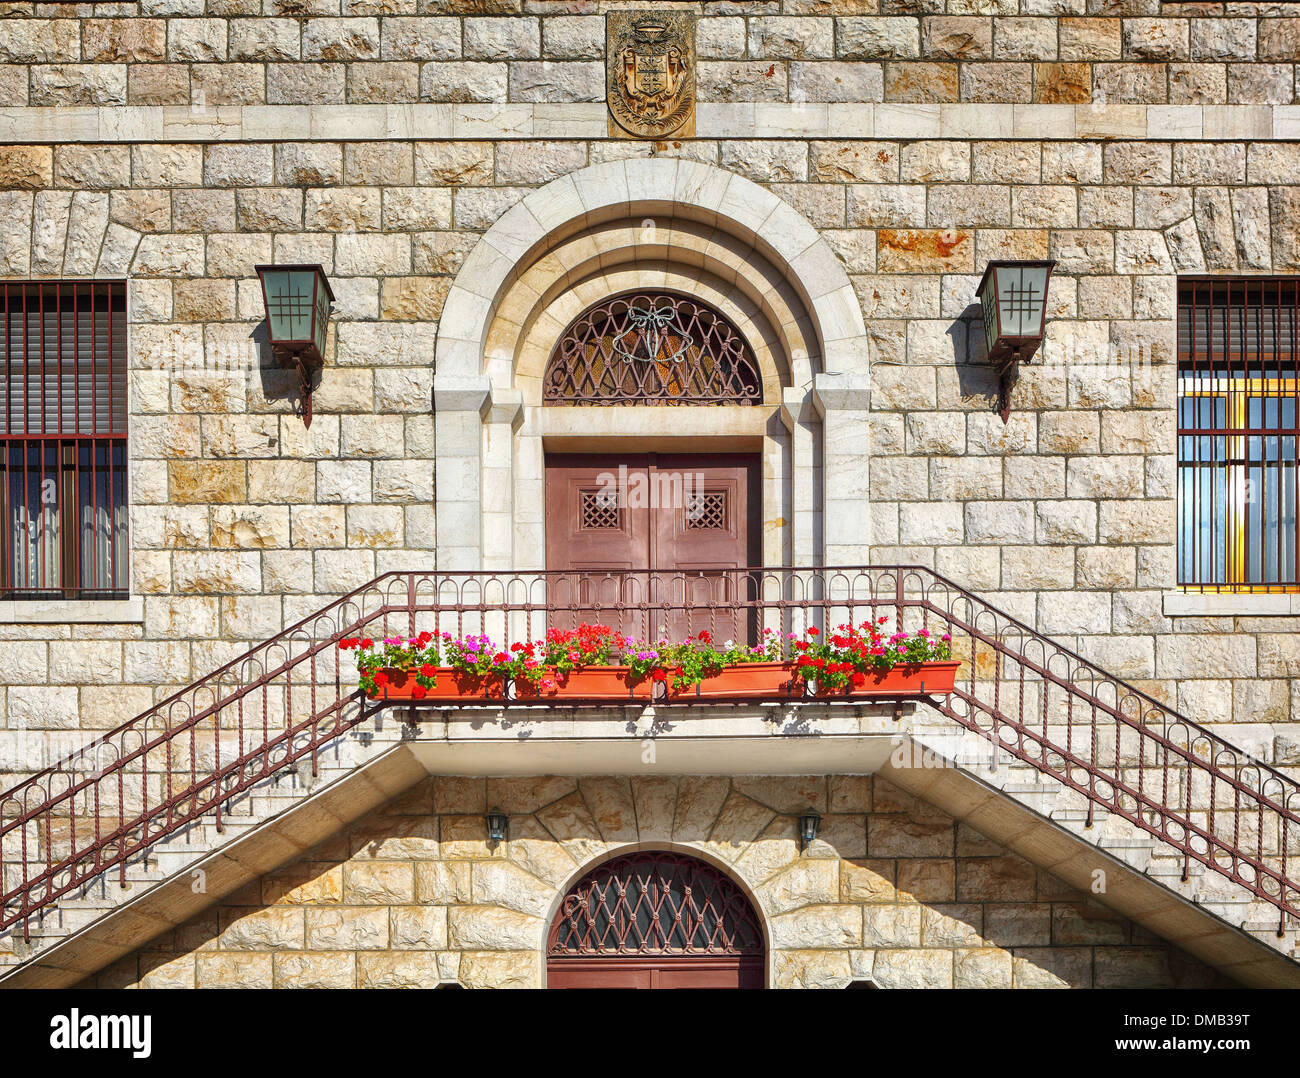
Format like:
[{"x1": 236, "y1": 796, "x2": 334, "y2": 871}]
[{"x1": 0, "y1": 567, "x2": 1300, "y2": 932}]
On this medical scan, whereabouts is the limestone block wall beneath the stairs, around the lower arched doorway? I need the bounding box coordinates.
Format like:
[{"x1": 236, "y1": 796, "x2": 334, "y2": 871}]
[{"x1": 76, "y1": 776, "x2": 1223, "y2": 988}]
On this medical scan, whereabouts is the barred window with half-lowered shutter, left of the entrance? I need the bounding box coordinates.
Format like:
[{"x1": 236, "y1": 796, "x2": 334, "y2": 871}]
[{"x1": 0, "y1": 281, "x2": 129, "y2": 599}]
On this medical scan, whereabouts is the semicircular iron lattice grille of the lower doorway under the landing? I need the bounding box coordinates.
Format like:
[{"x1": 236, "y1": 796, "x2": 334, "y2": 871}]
[{"x1": 547, "y1": 853, "x2": 763, "y2": 957}]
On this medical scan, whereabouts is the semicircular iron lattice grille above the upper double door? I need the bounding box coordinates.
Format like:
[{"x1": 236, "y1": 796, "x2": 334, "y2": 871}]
[{"x1": 543, "y1": 293, "x2": 763, "y2": 404}]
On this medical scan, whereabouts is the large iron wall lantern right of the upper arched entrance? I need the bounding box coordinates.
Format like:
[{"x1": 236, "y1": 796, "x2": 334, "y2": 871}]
[{"x1": 975, "y1": 261, "x2": 1056, "y2": 423}]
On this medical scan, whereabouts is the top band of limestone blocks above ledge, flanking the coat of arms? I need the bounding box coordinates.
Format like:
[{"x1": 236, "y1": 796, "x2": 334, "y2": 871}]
[{"x1": 0, "y1": 0, "x2": 1300, "y2": 107}]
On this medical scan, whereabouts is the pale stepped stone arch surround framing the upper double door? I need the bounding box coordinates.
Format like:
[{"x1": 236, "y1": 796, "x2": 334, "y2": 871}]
[{"x1": 434, "y1": 159, "x2": 870, "y2": 570}]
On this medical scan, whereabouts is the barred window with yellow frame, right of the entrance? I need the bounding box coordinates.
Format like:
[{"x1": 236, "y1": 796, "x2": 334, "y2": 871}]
[{"x1": 1178, "y1": 278, "x2": 1300, "y2": 592}]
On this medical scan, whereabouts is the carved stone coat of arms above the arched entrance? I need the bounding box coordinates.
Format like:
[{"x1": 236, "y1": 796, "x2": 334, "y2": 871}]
[{"x1": 606, "y1": 12, "x2": 696, "y2": 138}]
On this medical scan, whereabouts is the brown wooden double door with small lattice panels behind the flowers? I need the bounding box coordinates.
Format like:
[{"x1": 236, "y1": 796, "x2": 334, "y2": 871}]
[{"x1": 546, "y1": 454, "x2": 759, "y2": 638}]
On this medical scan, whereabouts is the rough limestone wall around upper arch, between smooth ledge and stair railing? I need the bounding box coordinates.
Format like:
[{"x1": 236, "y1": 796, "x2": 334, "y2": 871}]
[{"x1": 0, "y1": 128, "x2": 1300, "y2": 771}]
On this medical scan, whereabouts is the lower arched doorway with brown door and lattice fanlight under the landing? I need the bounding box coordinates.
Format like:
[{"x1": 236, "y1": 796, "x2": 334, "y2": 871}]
[{"x1": 546, "y1": 850, "x2": 764, "y2": 988}]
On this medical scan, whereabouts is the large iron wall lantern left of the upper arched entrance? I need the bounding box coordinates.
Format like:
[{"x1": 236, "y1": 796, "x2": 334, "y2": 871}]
[{"x1": 255, "y1": 265, "x2": 334, "y2": 427}]
